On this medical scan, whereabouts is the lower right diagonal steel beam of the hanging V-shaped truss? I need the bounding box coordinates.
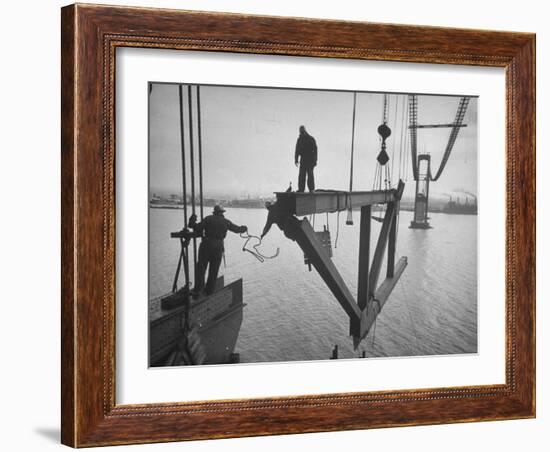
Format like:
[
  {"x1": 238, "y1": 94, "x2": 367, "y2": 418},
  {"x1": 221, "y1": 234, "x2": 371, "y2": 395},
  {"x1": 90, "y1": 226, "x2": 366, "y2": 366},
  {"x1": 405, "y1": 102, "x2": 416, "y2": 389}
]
[{"x1": 356, "y1": 256, "x2": 407, "y2": 349}]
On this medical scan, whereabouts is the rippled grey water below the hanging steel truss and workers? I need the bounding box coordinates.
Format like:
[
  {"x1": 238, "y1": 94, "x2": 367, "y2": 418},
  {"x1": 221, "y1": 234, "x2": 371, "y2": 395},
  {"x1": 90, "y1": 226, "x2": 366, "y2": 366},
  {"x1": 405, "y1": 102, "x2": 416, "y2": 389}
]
[{"x1": 149, "y1": 208, "x2": 477, "y2": 362}]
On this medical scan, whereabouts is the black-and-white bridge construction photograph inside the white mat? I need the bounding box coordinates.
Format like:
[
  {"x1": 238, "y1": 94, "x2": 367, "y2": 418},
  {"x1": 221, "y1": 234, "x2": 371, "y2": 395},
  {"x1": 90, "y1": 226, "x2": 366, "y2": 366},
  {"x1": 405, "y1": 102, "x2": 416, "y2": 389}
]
[{"x1": 150, "y1": 80, "x2": 478, "y2": 367}]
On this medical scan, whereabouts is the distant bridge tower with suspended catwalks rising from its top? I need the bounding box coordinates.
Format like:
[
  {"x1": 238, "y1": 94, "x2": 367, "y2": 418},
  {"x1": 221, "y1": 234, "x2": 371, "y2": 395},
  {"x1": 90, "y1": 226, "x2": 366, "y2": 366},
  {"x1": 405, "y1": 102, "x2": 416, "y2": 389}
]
[{"x1": 409, "y1": 94, "x2": 470, "y2": 229}]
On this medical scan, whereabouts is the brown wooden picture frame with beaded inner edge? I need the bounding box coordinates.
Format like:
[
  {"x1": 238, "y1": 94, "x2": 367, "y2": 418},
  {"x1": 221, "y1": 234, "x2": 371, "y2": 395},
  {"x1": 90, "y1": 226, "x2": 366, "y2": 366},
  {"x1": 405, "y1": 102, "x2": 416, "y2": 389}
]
[{"x1": 61, "y1": 4, "x2": 535, "y2": 447}]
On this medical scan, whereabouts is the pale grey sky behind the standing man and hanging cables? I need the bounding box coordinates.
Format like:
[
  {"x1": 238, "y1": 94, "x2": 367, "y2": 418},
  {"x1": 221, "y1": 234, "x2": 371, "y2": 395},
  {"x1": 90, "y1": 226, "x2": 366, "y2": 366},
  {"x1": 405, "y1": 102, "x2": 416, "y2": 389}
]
[{"x1": 149, "y1": 84, "x2": 477, "y2": 201}]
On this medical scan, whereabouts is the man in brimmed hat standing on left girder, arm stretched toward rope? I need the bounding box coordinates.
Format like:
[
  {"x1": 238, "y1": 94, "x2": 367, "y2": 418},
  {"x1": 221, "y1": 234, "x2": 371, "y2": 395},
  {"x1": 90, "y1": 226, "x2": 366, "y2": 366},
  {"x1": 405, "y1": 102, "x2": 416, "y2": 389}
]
[{"x1": 189, "y1": 205, "x2": 248, "y2": 295}]
